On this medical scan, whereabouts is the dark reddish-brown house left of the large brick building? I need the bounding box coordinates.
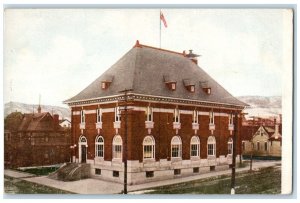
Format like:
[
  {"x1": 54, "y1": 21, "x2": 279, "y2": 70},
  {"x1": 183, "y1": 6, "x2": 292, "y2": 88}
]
[{"x1": 4, "y1": 107, "x2": 71, "y2": 168}]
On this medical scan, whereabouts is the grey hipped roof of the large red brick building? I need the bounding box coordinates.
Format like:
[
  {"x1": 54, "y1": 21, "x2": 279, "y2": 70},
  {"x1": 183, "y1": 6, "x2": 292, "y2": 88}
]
[{"x1": 65, "y1": 42, "x2": 247, "y2": 106}]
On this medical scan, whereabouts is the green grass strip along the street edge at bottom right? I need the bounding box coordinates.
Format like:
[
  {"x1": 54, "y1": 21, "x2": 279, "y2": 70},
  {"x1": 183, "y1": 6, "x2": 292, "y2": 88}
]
[{"x1": 145, "y1": 166, "x2": 281, "y2": 194}]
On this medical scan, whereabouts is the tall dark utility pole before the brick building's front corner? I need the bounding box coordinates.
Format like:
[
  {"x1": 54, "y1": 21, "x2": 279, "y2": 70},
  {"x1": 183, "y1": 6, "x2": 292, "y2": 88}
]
[{"x1": 120, "y1": 89, "x2": 133, "y2": 194}]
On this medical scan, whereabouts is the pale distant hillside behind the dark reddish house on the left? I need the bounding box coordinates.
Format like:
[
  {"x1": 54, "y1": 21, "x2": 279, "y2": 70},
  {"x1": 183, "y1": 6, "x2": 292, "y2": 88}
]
[{"x1": 4, "y1": 102, "x2": 71, "y2": 119}]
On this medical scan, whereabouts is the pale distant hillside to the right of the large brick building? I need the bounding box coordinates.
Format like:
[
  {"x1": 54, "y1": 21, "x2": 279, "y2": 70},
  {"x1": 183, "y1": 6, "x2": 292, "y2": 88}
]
[{"x1": 237, "y1": 96, "x2": 282, "y2": 118}]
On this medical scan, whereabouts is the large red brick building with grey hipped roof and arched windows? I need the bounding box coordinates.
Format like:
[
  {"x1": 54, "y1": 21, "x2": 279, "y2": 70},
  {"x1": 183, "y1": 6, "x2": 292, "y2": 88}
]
[{"x1": 65, "y1": 41, "x2": 246, "y2": 184}]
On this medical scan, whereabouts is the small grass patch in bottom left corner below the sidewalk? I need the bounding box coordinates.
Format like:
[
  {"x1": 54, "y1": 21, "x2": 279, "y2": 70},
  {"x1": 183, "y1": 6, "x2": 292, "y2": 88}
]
[{"x1": 4, "y1": 176, "x2": 72, "y2": 194}]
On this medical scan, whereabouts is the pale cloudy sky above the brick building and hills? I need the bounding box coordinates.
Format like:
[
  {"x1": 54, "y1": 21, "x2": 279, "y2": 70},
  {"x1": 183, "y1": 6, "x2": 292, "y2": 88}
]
[{"x1": 3, "y1": 9, "x2": 292, "y2": 106}]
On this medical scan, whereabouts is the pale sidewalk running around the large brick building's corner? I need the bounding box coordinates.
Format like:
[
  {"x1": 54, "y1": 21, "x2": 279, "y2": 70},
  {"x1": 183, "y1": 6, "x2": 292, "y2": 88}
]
[{"x1": 4, "y1": 161, "x2": 281, "y2": 194}]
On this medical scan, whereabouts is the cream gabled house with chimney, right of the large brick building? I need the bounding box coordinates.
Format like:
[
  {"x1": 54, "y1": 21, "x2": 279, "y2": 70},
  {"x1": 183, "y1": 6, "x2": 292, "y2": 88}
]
[{"x1": 241, "y1": 117, "x2": 282, "y2": 159}]
